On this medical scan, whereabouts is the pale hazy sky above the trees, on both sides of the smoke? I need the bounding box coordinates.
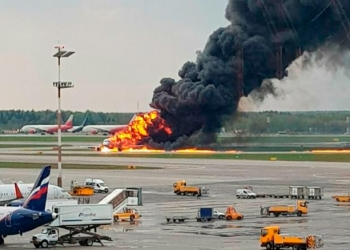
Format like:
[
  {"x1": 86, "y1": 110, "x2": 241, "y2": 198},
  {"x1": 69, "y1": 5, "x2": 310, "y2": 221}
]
[{"x1": 0, "y1": 0, "x2": 350, "y2": 112}]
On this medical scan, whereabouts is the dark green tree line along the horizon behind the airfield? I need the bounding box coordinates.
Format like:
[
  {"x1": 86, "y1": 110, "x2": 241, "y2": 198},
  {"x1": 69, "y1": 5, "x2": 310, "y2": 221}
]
[{"x1": 0, "y1": 110, "x2": 350, "y2": 134}]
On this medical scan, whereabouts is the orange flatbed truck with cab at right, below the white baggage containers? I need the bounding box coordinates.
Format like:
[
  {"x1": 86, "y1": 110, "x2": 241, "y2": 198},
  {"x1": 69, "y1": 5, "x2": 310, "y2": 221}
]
[{"x1": 260, "y1": 200, "x2": 309, "y2": 217}]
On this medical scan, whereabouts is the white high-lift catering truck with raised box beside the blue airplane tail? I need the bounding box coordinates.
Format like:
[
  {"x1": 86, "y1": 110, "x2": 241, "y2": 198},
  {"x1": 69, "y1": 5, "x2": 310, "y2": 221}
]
[{"x1": 30, "y1": 204, "x2": 113, "y2": 248}]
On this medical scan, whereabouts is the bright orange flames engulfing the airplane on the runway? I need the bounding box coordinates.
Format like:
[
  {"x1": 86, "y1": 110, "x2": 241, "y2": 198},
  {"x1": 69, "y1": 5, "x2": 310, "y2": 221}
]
[{"x1": 101, "y1": 110, "x2": 172, "y2": 152}]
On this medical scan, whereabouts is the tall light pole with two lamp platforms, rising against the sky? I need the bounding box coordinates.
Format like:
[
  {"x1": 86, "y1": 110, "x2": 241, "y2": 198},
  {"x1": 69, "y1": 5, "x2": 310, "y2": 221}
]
[{"x1": 53, "y1": 46, "x2": 75, "y2": 187}]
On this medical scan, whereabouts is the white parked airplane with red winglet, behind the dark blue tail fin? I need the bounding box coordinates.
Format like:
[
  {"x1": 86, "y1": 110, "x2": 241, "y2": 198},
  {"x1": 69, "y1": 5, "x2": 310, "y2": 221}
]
[{"x1": 0, "y1": 183, "x2": 72, "y2": 206}]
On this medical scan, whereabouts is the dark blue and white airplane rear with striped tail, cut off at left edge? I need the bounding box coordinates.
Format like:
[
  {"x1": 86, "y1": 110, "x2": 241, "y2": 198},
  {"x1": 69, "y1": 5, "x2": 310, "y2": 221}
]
[{"x1": 0, "y1": 166, "x2": 58, "y2": 245}]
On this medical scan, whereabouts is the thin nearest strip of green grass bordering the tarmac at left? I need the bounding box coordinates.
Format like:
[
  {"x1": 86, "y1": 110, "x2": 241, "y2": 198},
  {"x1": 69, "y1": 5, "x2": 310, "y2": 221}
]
[{"x1": 0, "y1": 162, "x2": 161, "y2": 170}]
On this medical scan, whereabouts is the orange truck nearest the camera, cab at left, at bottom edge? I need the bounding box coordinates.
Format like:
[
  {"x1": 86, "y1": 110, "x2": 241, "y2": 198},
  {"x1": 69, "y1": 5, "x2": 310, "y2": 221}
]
[{"x1": 260, "y1": 226, "x2": 323, "y2": 250}]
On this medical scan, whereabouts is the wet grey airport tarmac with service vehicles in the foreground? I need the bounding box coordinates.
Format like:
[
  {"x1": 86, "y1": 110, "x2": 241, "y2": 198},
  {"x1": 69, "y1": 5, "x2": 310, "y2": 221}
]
[{"x1": 0, "y1": 155, "x2": 350, "y2": 250}]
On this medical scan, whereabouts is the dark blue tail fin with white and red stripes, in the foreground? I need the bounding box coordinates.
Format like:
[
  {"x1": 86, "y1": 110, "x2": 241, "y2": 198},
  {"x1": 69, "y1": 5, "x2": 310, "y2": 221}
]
[{"x1": 23, "y1": 166, "x2": 51, "y2": 211}]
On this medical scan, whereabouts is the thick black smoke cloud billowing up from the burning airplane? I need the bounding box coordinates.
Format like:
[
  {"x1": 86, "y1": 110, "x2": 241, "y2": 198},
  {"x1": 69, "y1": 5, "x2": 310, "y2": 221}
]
[{"x1": 150, "y1": 0, "x2": 350, "y2": 148}]
